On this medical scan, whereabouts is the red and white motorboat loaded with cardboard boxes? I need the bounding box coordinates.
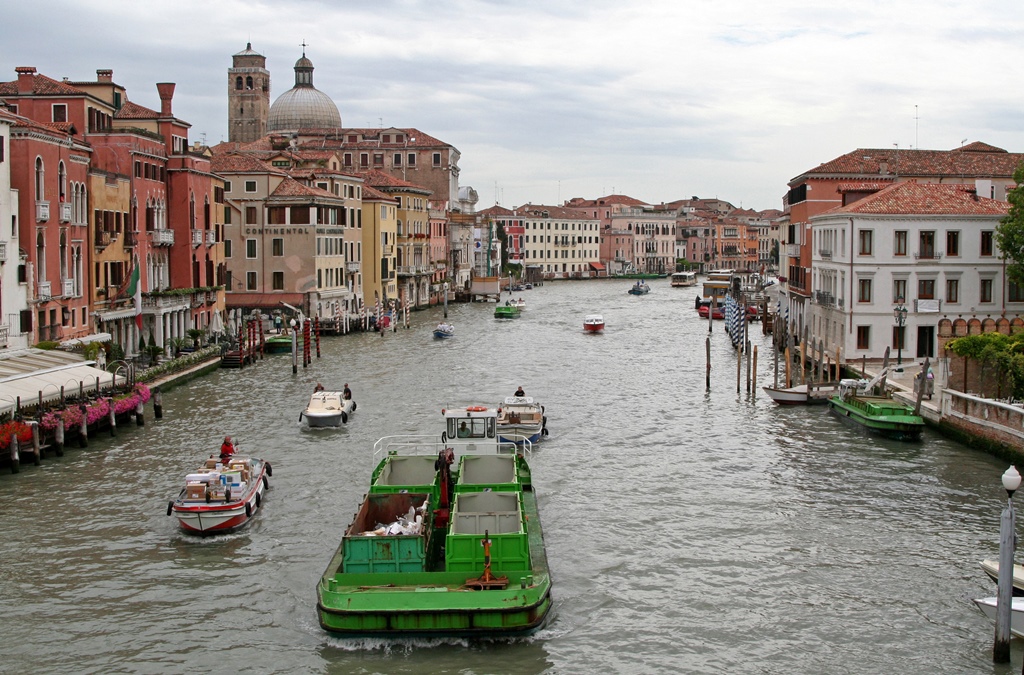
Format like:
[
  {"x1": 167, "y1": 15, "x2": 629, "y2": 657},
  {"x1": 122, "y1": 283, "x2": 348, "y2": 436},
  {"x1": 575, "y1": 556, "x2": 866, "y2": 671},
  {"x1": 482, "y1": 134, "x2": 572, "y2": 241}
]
[{"x1": 167, "y1": 455, "x2": 273, "y2": 535}]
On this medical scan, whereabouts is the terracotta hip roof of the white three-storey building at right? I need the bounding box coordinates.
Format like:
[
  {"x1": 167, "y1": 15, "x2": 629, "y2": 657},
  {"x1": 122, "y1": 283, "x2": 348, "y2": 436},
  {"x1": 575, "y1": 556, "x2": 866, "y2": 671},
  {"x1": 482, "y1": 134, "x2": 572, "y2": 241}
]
[{"x1": 812, "y1": 181, "x2": 1010, "y2": 219}]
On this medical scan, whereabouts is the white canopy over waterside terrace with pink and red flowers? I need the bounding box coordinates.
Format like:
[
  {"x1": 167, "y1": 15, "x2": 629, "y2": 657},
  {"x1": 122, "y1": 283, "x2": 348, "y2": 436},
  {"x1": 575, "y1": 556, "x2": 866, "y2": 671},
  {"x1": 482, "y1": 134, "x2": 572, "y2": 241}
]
[{"x1": 0, "y1": 349, "x2": 126, "y2": 414}]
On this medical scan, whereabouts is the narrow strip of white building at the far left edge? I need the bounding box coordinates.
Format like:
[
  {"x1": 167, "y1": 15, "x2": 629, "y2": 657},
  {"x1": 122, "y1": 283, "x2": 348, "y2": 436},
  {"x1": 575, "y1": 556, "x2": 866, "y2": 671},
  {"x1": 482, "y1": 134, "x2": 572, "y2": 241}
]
[{"x1": 0, "y1": 111, "x2": 31, "y2": 349}]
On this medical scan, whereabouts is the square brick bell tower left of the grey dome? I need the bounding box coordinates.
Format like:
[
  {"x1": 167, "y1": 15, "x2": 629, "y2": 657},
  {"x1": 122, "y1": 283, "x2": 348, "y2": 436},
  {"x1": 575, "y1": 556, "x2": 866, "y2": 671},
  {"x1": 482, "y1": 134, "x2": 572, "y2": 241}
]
[{"x1": 227, "y1": 42, "x2": 270, "y2": 143}]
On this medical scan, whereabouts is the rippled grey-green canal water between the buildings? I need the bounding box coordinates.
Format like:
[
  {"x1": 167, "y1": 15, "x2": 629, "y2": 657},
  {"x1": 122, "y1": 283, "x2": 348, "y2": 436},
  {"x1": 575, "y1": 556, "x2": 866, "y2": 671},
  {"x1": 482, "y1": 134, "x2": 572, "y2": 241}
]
[{"x1": 0, "y1": 280, "x2": 1024, "y2": 674}]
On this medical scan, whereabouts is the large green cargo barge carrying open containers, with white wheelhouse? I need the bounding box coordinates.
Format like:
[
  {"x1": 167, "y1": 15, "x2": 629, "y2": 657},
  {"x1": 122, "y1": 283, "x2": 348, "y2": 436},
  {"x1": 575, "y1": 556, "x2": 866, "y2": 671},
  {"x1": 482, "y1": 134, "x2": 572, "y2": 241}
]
[{"x1": 316, "y1": 407, "x2": 551, "y2": 637}]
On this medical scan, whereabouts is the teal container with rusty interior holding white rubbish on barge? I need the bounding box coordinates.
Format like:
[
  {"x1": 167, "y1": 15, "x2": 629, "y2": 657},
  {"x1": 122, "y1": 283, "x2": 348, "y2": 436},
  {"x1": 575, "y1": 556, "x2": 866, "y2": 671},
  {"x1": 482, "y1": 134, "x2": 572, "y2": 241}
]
[{"x1": 341, "y1": 493, "x2": 432, "y2": 573}]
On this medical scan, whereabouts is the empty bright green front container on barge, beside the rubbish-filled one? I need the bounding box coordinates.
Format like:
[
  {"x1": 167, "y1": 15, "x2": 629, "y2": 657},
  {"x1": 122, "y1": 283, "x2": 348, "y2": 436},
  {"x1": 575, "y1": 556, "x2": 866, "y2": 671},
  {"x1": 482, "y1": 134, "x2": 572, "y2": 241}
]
[{"x1": 444, "y1": 492, "x2": 529, "y2": 574}]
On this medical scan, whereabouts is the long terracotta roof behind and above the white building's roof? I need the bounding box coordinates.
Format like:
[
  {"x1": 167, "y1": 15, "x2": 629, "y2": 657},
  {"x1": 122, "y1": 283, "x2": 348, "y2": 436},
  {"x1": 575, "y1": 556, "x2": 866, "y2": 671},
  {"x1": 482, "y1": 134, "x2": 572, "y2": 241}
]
[{"x1": 790, "y1": 143, "x2": 1024, "y2": 185}]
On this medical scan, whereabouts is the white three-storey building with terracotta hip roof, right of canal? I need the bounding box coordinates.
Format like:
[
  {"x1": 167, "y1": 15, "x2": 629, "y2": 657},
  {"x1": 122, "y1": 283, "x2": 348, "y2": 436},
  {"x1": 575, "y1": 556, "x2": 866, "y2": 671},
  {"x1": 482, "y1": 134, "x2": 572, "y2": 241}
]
[{"x1": 808, "y1": 182, "x2": 1024, "y2": 362}]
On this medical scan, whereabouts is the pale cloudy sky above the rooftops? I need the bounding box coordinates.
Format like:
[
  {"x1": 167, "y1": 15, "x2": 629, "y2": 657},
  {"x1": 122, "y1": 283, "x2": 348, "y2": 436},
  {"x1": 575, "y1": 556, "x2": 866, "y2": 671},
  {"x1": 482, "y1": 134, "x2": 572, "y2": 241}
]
[{"x1": 0, "y1": 0, "x2": 1024, "y2": 209}]
